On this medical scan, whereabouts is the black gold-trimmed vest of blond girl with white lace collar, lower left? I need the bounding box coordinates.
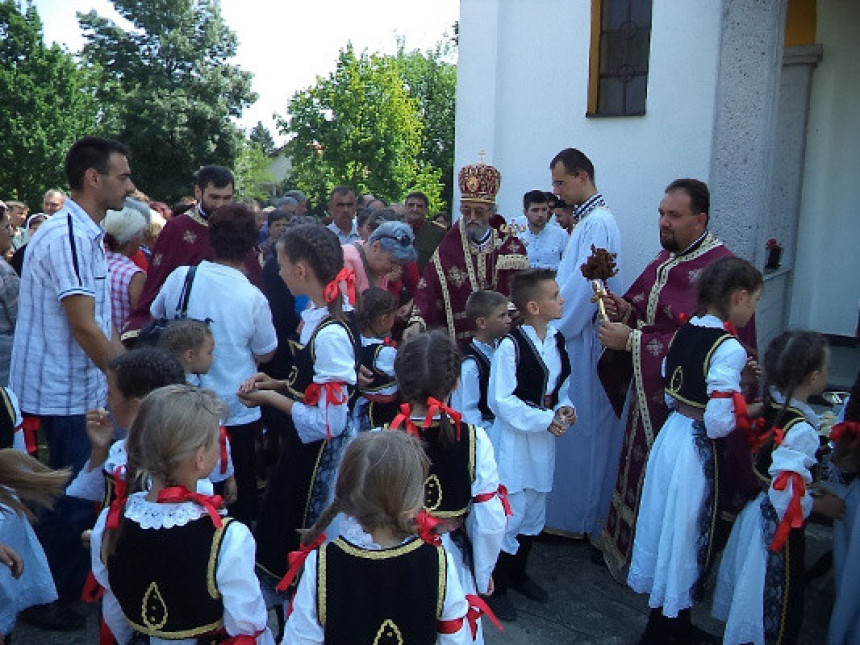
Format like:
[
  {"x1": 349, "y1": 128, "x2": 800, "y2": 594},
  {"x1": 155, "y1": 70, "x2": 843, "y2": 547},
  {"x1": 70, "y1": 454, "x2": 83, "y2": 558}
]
[{"x1": 102, "y1": 514, "x2": 231, "y2": 640}]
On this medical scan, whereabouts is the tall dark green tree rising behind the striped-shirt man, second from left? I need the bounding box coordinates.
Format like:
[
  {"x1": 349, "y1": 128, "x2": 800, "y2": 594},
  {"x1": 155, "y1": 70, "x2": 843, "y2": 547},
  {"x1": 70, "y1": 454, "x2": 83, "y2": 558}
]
[{"x1": 78, "y1": 0, "x2": 256, "y2": 201}]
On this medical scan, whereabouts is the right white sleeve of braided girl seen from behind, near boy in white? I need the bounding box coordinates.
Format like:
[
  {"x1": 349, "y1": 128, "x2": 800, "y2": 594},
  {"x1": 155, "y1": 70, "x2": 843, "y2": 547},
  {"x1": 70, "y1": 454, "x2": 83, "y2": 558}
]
[{"x1": 466, "y1": 426, "x2": 507, "y2": 594}]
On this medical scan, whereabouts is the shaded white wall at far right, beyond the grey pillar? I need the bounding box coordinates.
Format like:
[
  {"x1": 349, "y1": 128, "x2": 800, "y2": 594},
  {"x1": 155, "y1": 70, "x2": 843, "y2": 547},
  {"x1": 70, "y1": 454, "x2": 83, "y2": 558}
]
[{"x1": 789, "y1": 0, "x2": 860, "y2": 336}]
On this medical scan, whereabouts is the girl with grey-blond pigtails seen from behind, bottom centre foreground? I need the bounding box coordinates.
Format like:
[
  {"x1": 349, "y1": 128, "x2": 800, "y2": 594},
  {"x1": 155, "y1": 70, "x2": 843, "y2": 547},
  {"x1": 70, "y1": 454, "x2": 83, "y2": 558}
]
[{"x1": 284, "y1": 432, "x2": 473, "y2": 645}]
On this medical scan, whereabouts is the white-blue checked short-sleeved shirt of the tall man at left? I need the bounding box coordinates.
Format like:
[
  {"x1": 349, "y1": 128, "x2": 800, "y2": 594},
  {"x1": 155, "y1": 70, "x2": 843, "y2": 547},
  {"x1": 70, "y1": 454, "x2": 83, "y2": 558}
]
[{"x1": 9, "y1": 199, "x2": 112, "y2": 416}]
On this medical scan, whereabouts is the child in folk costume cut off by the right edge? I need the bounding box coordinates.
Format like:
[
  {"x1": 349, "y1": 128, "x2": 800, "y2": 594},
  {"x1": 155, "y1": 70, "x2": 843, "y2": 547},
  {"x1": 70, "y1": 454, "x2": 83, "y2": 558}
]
[{"x1": 827, "y1": 374, "x2": 860, "y2": 645}]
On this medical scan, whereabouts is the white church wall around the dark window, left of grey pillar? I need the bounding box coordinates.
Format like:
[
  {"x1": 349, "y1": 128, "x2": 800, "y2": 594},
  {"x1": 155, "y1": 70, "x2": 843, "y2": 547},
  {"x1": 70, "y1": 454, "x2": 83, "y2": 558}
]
[{"x1": 455, "y1": 0, "x2": 721, "y2": 288}]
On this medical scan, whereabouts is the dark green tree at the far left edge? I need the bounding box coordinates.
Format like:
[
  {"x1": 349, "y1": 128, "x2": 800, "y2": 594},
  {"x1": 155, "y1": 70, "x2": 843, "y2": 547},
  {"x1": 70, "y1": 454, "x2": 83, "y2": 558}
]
[{"x1": 0, "y1": 0, "x2": 106, "y2": 206}]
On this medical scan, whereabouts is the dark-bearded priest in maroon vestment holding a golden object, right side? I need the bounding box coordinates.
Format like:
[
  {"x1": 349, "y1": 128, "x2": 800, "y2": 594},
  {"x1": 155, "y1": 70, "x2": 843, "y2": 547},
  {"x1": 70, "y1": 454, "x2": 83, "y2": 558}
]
[{"x1": 598, "y1": 179, "x2": 756, "y2": 583}]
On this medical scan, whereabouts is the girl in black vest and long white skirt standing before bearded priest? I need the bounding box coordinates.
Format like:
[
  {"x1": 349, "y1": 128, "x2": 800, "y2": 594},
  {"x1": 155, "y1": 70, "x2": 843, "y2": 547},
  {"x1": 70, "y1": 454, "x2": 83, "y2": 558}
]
[{"x1": 627, "y1": 257, "x2": 762, "y2": 643}]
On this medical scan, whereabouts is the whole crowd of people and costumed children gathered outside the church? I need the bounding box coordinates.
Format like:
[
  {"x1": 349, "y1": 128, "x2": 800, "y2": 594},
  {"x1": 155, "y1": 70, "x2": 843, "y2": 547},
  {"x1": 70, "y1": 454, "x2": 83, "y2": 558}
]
[{"x1": 0, "y1": 137, "x2": 860, "y2": 645}]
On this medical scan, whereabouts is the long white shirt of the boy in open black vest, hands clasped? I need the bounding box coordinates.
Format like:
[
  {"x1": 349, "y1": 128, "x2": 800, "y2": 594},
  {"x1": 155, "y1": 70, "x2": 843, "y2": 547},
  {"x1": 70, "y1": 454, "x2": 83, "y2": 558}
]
[{"x1": 487, "y1": 325, "x2": 576, "y2": 493}]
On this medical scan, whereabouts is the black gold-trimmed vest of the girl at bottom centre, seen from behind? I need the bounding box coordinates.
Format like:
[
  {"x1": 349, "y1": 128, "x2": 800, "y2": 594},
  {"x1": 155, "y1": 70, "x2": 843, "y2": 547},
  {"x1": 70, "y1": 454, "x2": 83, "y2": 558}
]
[{"x1": 317, "y1": 538, "x2": 446, "y2": 645}]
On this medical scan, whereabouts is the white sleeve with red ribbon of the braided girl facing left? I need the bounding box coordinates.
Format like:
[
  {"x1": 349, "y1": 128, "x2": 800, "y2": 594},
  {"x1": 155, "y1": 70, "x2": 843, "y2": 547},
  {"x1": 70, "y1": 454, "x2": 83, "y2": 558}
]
[{"x1": 292, "y1": 325, "x2": 356, "y2": 443}]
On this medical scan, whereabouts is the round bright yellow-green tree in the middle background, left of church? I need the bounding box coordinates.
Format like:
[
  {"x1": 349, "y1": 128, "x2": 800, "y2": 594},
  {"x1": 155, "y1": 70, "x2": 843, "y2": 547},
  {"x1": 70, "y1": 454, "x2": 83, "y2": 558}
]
[{"x1": 278, "y1": 45, "x2": 442, "y2": 216}]
